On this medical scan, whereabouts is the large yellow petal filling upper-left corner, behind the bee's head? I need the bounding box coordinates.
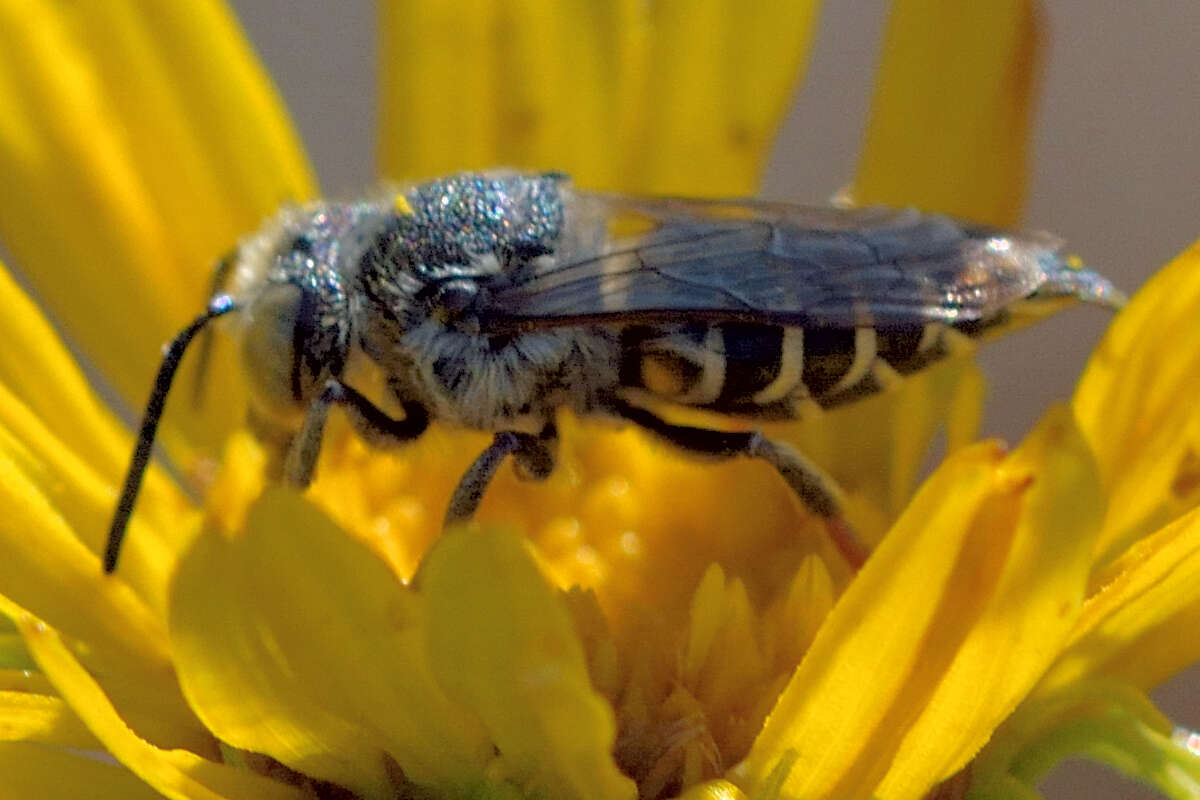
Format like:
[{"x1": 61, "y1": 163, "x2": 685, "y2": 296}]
[{"x1": 0, "y1": 0, "x2": 312, "y2": 438}]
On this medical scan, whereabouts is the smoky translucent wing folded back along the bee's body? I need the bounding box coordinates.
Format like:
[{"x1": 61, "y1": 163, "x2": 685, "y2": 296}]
[{"x1": 484, "y1": 191, "x2": 1080, "y2": 330}]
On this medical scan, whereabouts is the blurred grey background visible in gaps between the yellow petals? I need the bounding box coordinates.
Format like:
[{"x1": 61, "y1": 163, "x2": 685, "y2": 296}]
[{"x1": 232, "y1": 0, "x2": 1200, "y2": 799}]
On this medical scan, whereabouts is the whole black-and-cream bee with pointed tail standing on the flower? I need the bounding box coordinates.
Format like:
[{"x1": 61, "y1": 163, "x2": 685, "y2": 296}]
[{"x1": 104, "y1": 170, "x2": 1122, "y2": 572}]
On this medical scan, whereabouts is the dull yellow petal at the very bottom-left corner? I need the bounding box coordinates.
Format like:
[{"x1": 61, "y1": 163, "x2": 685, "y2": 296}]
[{"x1": 0, "y1": 741, "x2": 162, "y2": 800}]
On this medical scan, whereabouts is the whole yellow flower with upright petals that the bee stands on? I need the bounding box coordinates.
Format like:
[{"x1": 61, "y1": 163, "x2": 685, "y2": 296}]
[{"x1": 0, "y1": 0, "x2": 1200, "y2": 800}]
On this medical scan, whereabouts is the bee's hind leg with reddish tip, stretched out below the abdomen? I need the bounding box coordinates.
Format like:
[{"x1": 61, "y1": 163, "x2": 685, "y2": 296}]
[{"x1": 606, "y1": 398, "x2": 868, "y2": 570}]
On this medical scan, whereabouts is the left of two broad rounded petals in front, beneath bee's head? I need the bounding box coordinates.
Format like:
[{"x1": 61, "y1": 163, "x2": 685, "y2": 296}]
[{"x1": 170, "y1": 489, "x2": 490, "y2": 798}]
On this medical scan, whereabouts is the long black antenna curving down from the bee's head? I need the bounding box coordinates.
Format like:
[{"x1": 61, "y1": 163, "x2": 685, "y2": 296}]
[{"x1": 104, "y1": 294, "x2": 238, "y2": 573}]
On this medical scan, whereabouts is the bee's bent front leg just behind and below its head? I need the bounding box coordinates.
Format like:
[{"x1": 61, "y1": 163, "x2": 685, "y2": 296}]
[{"x1": 283, "y1": 378, "x2": 430, "y2": 488}]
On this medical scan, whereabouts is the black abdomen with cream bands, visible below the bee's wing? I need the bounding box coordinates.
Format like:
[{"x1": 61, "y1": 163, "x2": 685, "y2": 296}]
[{"x1": 620, "y1": 323, "x2": 990, "y2": 419}]
